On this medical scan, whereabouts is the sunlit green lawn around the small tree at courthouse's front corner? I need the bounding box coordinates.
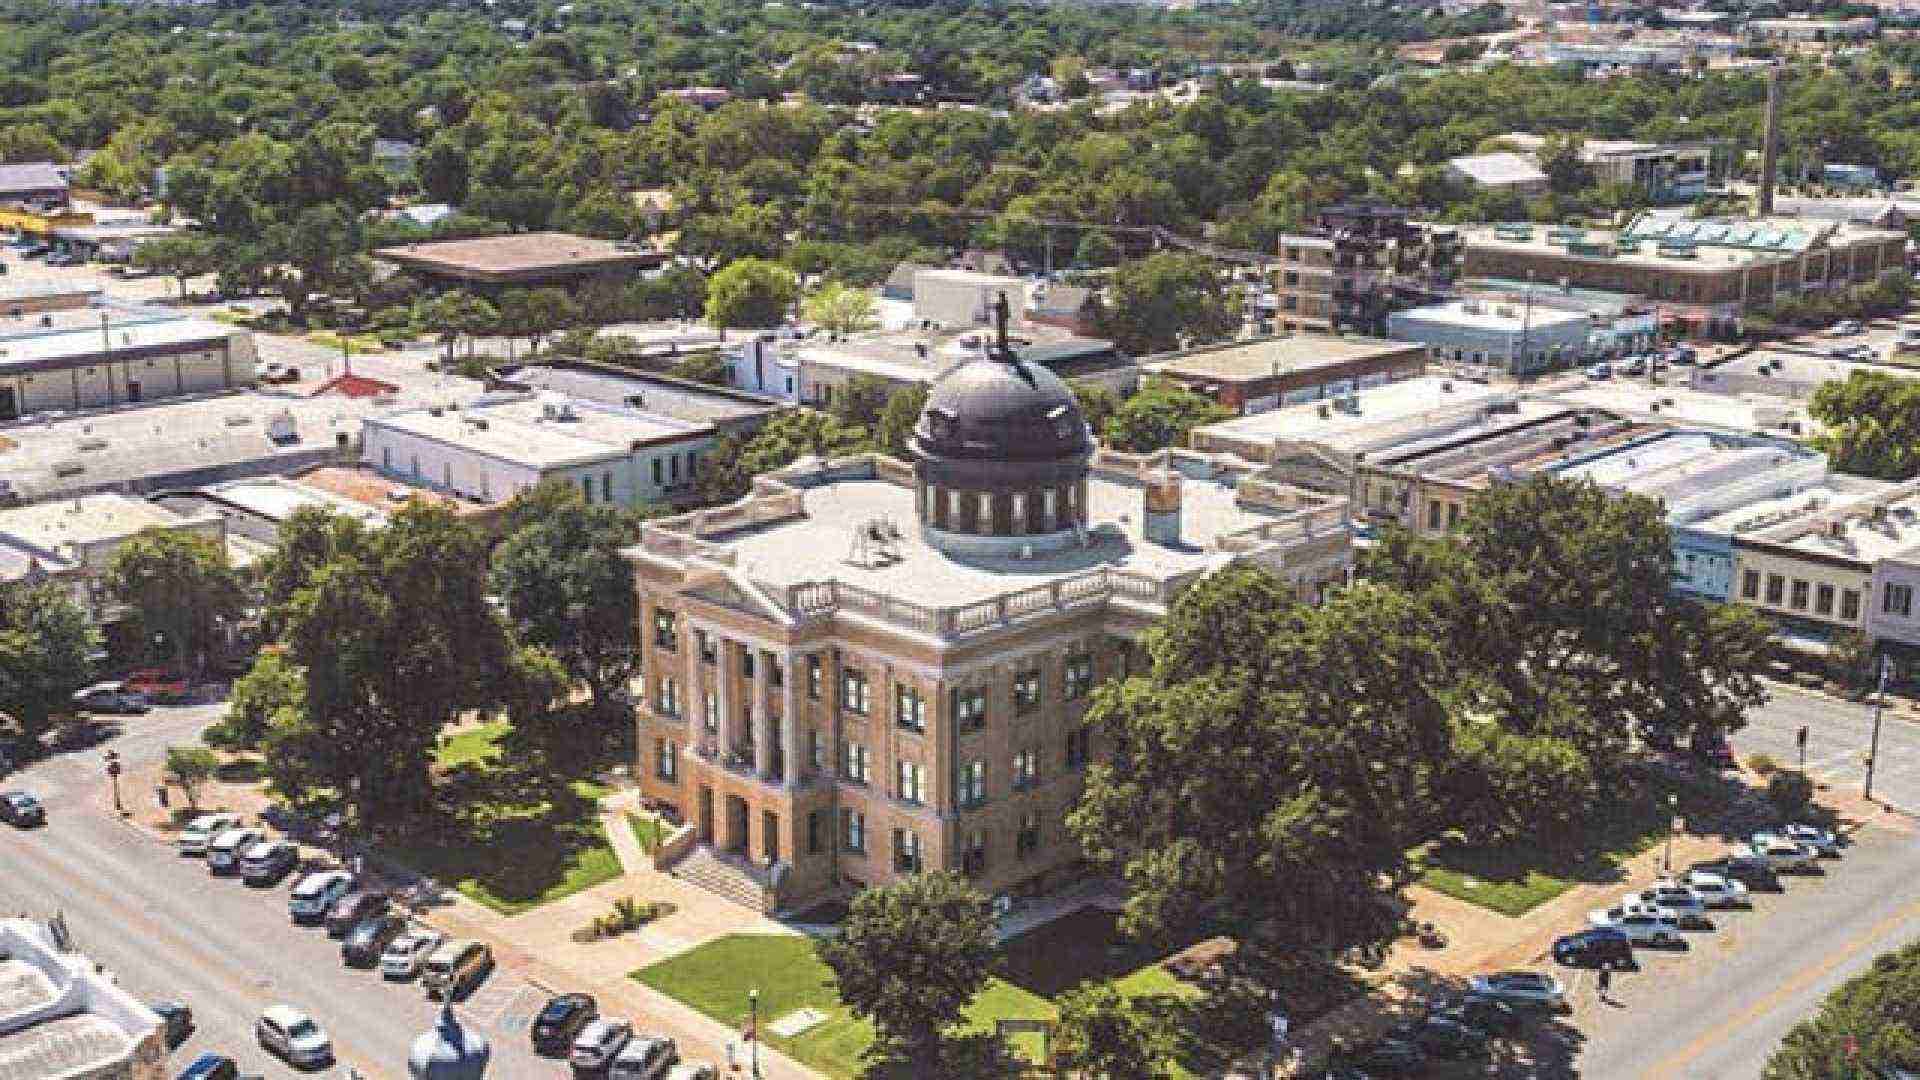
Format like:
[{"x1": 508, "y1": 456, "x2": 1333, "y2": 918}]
[{"x1": 634, "y1": 934, "x2": 1056, "y2": 1076}]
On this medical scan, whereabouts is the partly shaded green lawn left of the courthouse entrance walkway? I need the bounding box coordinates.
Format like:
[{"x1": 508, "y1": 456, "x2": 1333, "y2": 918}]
[{"x1": 388, "y1": 723, "x2": 620, "y2": 915}]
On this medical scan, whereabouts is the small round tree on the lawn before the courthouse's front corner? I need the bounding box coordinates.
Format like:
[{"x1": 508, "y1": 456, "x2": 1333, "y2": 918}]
[{"x1": 814, "y1": 871, "x2": 993, "y2": 1074}]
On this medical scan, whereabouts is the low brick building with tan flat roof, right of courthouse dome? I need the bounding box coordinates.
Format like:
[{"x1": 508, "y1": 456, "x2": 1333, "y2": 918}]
[{"x1": 1140, "y1": 332, "x2": 1427, "y2": 415}]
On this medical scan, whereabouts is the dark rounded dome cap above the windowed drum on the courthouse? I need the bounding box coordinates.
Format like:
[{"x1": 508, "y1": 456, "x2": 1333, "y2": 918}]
[{"x1": 914, "y1": 357, "x2": 1092, "y2": 461}]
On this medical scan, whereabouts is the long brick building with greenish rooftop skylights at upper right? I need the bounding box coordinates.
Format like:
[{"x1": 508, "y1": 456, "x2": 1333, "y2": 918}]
[{"x1": 1461, "y1": 215, "x2": 1907, "y2": 334}]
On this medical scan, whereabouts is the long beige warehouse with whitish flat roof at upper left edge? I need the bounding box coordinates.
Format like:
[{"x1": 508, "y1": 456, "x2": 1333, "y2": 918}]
[{"x1": 0, "y1": 304, "x2": 255, "y2": 423}]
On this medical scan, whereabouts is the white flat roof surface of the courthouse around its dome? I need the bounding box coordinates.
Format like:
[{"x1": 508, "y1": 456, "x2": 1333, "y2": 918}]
[{"x1": 707, "y1": 471, "x2": 1313, "y2": 607}]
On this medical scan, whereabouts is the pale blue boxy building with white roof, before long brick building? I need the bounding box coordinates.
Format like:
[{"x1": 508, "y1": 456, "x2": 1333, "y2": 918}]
[{"x1": 1386, "y1": 300, "x2": 1594, "y2": 377}]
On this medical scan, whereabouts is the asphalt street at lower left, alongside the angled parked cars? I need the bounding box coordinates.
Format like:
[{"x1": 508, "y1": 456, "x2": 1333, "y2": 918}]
[{"x1": 0, "y1": 705, "x2": 568, "y2": 1078}]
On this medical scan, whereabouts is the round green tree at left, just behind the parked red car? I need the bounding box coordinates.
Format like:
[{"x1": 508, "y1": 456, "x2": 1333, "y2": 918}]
[{"x1": 106, "y1": 528, "x2": 248, "y2": 671}]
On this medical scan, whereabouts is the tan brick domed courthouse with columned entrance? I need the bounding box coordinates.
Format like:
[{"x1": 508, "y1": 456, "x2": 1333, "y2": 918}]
[{"x1": 630, "y1": 332, "x2": 1350, "y2": 909}]
